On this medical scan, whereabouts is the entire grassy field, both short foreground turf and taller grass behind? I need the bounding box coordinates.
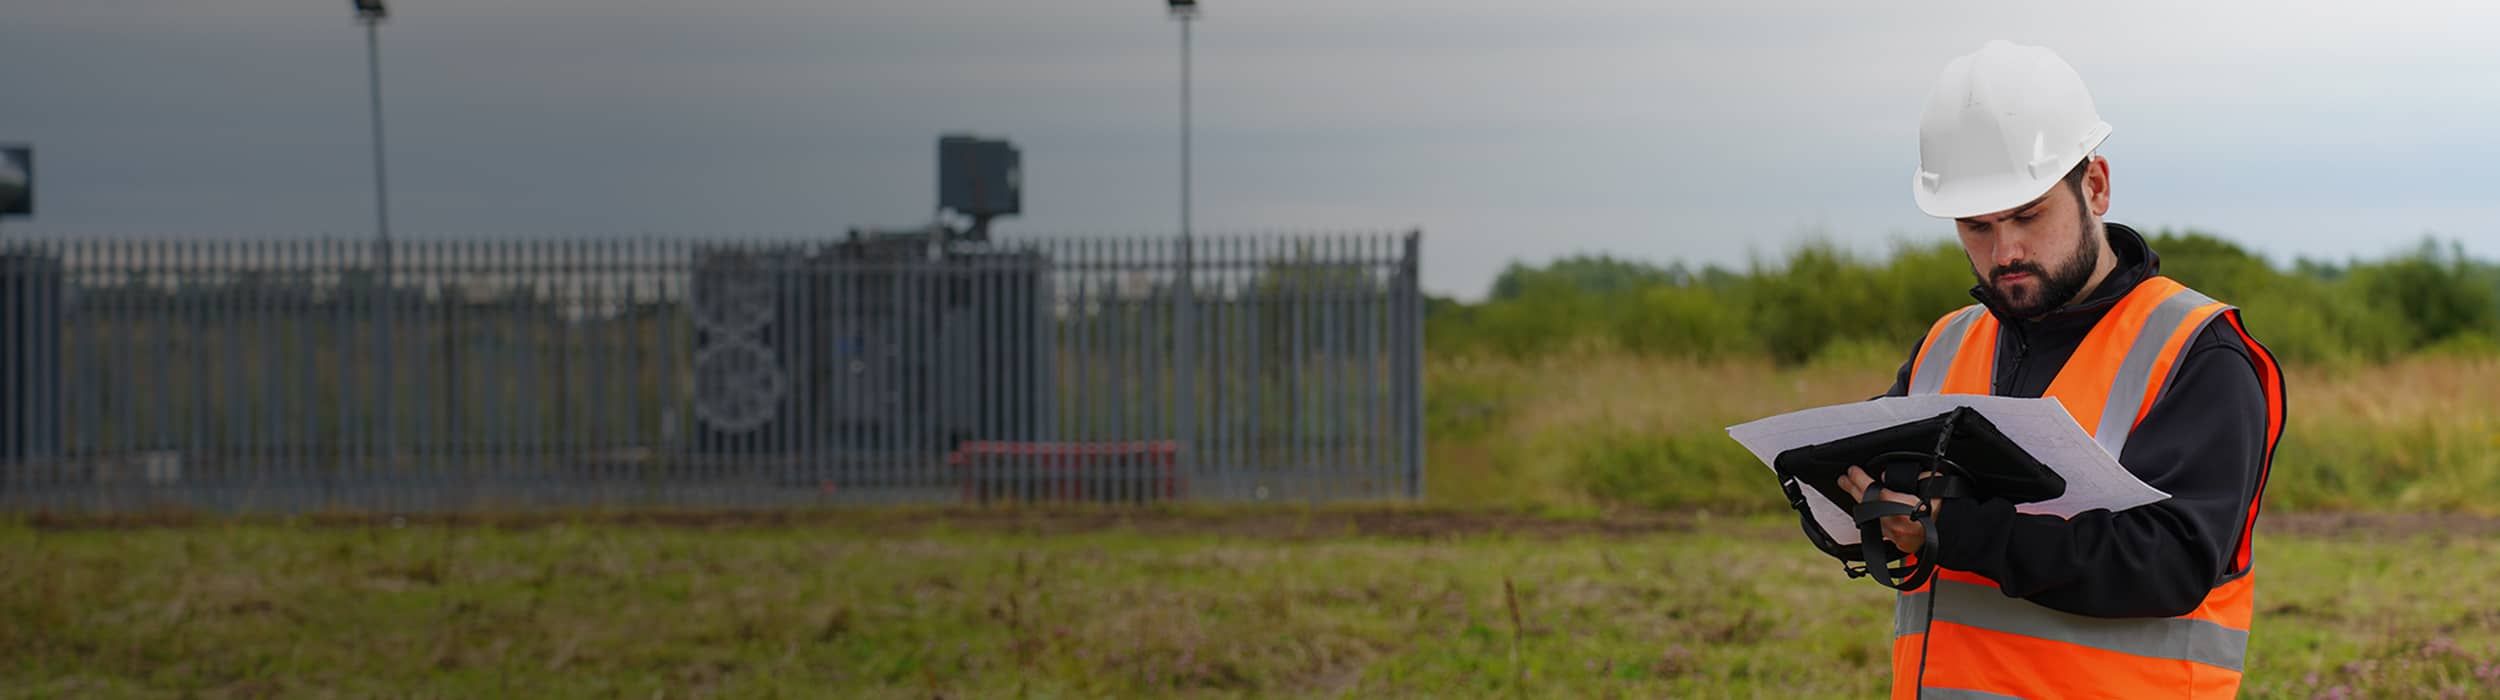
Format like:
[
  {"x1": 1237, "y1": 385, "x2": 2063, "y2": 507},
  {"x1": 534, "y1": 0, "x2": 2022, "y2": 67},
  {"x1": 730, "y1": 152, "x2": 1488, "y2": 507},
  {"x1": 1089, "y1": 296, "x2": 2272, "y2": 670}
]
[{"x1": 0, "y1": 348, "x2": 2500, "y2": 698}]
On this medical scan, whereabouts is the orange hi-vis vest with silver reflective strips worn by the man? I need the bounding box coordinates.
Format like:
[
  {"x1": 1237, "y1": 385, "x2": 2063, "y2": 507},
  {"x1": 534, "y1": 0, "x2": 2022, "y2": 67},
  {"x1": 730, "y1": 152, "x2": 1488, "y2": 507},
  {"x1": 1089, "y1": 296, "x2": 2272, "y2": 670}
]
[{"x1": 1893, "y1": 278, "x2": 2283, "y2": 698}]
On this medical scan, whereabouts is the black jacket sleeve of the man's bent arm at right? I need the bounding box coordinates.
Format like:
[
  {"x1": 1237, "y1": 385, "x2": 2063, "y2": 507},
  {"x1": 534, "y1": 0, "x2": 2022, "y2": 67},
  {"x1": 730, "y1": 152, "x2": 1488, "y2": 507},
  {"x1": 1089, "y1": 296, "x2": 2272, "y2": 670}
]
[{"x1": 1935, "y1": 323, "x2": 2268, "y2": 618}]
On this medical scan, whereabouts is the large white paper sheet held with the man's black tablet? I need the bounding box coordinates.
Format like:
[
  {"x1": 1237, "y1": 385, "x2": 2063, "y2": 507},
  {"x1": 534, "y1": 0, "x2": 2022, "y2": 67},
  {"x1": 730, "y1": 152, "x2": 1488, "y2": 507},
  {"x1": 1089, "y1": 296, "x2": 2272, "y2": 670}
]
[{"x1": 1728, "y1": 395, "x2": 2170, "y2": 545}]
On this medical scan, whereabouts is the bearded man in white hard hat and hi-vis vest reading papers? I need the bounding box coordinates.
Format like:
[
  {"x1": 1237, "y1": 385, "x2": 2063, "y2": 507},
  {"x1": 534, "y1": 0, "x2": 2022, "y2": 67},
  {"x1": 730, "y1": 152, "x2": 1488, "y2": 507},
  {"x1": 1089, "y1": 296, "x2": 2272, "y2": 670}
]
[{"x1": 1843, "y1": 43, "x2": 2283, "y2": 698}]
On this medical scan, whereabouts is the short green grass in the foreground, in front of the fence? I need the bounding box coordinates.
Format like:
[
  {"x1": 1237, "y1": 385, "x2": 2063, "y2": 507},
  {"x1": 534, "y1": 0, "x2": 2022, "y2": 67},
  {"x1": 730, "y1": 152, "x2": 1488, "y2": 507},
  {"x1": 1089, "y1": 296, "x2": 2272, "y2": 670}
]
[{"x1": 0, "y1": 508, "x2": 2500, "y2": 698}]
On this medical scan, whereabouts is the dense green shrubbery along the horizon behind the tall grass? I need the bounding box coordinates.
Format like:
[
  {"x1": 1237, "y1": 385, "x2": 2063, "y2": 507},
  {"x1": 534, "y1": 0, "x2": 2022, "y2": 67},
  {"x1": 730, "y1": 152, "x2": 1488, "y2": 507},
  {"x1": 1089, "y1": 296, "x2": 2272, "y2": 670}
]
[{"x1": 1428, "y1": 230, "x2": 2500, "y2": 365}]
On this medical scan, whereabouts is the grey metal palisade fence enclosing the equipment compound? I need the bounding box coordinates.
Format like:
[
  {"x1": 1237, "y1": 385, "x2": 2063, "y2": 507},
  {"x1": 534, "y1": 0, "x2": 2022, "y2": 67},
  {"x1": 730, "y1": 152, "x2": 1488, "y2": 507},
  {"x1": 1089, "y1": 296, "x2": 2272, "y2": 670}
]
[{"x1": 0, "y1": 233, "x2": 1423, "y2": 513}]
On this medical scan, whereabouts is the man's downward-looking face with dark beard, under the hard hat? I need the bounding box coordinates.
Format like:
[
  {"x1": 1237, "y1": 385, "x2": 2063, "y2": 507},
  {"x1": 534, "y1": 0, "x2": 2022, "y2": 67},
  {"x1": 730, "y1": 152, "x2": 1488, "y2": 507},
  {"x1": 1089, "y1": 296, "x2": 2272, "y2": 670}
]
[{"x1": 1953, "y1": 168, "x2": 2108, "y2": 318}]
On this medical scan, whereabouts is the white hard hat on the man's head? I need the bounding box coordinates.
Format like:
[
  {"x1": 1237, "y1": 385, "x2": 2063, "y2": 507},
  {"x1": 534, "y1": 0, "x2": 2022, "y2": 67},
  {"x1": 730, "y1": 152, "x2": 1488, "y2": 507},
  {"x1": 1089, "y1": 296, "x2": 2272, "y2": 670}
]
[{"x1": 1910, "y1": 40, "x2": 2110, "y2": 218}]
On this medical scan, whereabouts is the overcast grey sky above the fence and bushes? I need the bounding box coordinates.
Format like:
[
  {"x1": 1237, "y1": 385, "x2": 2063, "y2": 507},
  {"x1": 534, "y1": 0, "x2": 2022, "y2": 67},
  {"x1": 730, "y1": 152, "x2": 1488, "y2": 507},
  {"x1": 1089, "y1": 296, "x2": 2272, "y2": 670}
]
[{"x1": 0, "y1": 0, "x2": 2500, "y2": 298}]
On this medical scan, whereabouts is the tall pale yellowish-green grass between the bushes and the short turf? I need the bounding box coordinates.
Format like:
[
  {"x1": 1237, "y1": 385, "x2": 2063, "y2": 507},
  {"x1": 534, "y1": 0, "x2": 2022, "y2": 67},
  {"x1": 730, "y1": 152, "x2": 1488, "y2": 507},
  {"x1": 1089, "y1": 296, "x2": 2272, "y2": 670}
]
[{"x1": 1425, "y1": 355, "x2": 2500, "y2": 515}]
